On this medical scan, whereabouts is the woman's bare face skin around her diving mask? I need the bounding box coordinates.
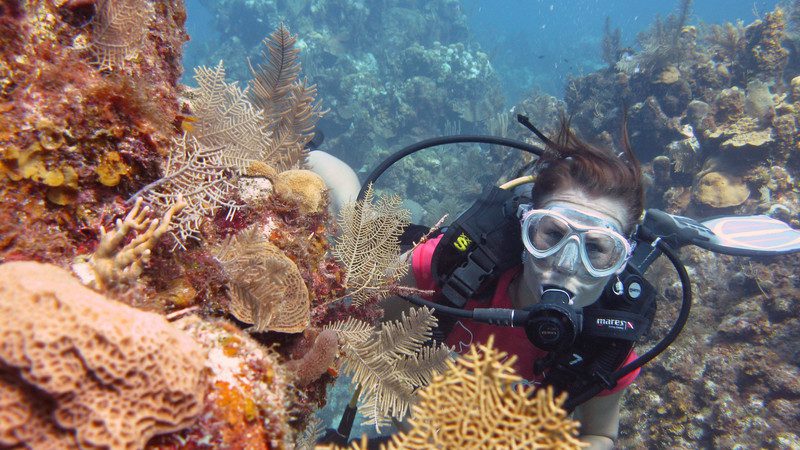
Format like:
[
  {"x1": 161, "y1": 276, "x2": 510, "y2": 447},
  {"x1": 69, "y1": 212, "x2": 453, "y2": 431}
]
[{"x1": 515, "y1": 189, "x2": 629, "y2": 309}]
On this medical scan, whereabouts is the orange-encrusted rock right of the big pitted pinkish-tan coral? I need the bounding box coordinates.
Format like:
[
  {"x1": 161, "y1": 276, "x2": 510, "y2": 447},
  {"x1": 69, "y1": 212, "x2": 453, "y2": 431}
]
[{"x1": 153, "y1": 317, "x2": 294, "y2": 450}]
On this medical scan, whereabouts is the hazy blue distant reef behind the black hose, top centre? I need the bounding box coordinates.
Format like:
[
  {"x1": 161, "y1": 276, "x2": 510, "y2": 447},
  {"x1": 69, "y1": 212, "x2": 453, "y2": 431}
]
[{"x1": 190, "y1": 0, "x2": 507, "y2": 224}]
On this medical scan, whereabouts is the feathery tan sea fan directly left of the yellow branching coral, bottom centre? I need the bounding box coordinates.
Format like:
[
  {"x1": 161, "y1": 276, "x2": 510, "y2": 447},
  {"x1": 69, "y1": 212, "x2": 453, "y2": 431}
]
[{"x1": 326, "y1": 307, "x2": 450, "y2": 430}]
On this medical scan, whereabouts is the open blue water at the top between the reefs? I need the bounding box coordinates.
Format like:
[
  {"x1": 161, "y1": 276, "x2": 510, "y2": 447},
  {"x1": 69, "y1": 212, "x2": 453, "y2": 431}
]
[{"x1": 184, "y1": 0, "x2": 779, "y2": 104}]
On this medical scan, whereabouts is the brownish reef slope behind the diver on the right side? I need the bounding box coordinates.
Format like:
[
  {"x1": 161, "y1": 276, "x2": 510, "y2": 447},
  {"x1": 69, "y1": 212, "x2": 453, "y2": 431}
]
[{"x1": 527, "y1": 0, "x2": 800, "y2": 448}]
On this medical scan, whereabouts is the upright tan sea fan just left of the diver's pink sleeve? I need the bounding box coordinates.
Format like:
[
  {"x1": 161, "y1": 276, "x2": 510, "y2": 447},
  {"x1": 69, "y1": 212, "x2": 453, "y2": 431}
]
[{"x1": 333, "y1": 185, "x2": 411, "y2": 304}]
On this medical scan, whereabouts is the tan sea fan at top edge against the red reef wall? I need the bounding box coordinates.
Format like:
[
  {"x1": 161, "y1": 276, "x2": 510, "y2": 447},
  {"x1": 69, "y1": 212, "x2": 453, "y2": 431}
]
[{"x1": 90, "y1": 0, "x2": 153, "y2": 70}]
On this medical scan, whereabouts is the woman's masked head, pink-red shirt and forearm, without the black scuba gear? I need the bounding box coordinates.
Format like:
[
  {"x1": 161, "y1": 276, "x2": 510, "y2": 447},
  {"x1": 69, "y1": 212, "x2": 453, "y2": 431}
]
[{"x1": 385, "y1": 120, "x2": 644, "y2": 449}]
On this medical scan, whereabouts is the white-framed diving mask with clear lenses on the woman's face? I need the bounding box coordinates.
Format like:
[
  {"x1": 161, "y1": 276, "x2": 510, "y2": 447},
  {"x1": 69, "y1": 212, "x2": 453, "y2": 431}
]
[{"x1": 521, "y1": 205, "x2": 632, "y2": 278}]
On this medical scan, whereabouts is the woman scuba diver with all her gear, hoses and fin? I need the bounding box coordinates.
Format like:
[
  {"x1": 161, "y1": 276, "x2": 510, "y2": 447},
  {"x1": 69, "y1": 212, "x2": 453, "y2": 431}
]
[{"x1": 323, "y1": 116, "x2": 800, "y2": 449}]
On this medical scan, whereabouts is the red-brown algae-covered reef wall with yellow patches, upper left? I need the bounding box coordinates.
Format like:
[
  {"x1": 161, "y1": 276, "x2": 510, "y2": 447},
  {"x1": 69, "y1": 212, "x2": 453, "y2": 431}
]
[{"x1": 0, "y1": 1, "x2": 186, "y2": 274}]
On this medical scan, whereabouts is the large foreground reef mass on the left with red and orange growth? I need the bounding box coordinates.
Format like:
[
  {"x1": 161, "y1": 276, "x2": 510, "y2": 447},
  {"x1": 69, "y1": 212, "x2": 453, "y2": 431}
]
[{"x1": 0, "y1": 0, "x2": 350, "y2": 449}]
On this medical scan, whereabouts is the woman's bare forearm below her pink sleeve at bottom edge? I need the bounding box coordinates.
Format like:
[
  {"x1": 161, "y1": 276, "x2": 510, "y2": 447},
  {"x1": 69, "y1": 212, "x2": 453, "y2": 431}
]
[{"x1": 575, "y1": 391, "x2": 622, "y2": 450}]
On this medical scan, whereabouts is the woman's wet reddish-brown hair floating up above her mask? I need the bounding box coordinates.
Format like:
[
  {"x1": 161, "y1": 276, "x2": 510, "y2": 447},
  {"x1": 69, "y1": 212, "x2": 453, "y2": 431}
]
[{"x1": 533, "y1": 115, "x2": 644, "y2": 232}]
